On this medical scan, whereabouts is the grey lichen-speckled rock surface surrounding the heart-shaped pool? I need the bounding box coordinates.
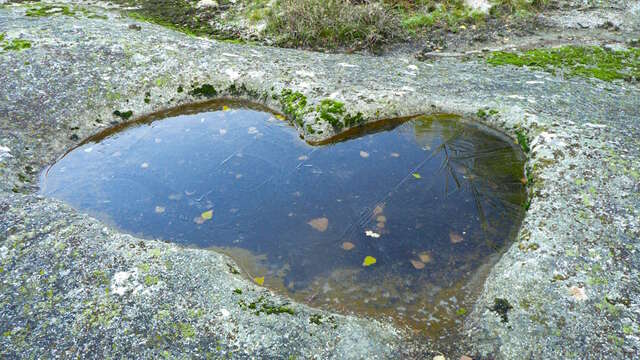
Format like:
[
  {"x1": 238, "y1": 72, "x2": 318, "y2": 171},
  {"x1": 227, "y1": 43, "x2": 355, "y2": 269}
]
[{"x1": 0, "y1": 1, "x2": 640, "y2": 359}]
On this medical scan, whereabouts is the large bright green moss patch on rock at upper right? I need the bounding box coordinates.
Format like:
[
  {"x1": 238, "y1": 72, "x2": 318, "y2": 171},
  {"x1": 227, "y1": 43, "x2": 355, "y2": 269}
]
[{"x1": 487, "y1": 46, "x2": 640, "y2": 81}]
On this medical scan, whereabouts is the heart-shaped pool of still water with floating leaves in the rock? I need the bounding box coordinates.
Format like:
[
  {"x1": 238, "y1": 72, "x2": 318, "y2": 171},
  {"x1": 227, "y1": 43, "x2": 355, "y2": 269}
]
[{"x1": 41, "y1": 103, "x2": 525, "y2": 336}]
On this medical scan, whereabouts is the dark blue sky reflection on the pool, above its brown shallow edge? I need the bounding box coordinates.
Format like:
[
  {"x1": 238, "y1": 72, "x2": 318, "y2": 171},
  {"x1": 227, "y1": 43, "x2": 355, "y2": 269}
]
[{"x1": 43, "y1": 110, "x2": 524, "y2": 290}]
